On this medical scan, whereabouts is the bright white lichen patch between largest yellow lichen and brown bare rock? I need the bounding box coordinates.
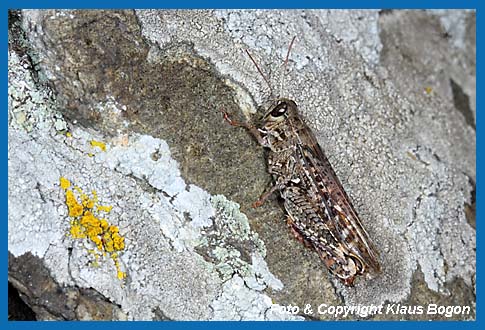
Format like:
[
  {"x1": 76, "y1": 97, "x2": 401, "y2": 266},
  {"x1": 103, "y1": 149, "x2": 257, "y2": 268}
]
[{"x1": 96, "y1": 136, "x2": 214, "y2": 252}]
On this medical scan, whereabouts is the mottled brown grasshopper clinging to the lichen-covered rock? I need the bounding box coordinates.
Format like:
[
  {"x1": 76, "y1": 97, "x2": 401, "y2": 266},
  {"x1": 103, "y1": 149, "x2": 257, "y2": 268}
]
[{"x1": 223, "y1": 38, "x2": 380, "y2": 286}]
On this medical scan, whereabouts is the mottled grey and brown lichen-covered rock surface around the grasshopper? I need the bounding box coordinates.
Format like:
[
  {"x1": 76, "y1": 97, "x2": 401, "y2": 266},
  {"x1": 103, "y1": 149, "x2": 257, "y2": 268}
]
[{"x1": 8, "y1": 10, "x2": 476, "y2": 320}]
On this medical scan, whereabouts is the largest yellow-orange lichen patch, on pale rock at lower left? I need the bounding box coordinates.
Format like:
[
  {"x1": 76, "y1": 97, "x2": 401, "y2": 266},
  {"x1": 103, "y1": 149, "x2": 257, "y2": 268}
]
[{"x1": 59, "y1": 177, "x2": 126, "y2": 280}]
